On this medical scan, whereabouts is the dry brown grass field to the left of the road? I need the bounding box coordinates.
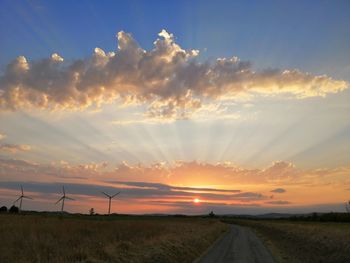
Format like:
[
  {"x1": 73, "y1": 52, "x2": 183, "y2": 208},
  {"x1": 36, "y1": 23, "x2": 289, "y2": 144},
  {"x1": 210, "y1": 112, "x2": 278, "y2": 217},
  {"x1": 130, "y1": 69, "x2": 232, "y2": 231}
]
[{"x1": 0, "y1": 215, "x2": 227, "y2": 263}]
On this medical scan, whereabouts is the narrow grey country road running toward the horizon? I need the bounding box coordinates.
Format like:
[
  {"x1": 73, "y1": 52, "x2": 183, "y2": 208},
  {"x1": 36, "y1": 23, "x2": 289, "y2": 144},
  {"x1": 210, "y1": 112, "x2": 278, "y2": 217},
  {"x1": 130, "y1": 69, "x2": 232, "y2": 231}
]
[{"x1": 198, "y1": 225, "x2": 275, "y2": 263}]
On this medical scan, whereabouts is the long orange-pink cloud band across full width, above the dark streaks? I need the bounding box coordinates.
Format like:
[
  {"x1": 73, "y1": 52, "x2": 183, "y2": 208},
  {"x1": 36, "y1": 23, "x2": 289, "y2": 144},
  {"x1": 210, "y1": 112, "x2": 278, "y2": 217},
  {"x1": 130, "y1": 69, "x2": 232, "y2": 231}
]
[{"x1": 0, "y1": 158, "x2": 350, "y2": 189}]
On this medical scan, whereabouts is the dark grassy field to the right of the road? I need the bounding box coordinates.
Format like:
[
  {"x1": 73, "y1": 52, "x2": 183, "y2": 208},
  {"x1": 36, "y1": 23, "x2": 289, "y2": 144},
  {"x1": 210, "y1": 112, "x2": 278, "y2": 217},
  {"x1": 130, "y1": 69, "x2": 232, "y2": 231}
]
[{"x1": 227, "y1": 220, "x2": 350, "y2": 263}]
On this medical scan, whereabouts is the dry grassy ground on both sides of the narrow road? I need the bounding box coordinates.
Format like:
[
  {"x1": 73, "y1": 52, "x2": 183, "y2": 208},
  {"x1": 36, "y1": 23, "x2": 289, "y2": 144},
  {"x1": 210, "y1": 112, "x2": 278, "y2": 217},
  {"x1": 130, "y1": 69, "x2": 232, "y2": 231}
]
[{"x1": 0, "y1": 213, "x2": 350, "y2": 263}]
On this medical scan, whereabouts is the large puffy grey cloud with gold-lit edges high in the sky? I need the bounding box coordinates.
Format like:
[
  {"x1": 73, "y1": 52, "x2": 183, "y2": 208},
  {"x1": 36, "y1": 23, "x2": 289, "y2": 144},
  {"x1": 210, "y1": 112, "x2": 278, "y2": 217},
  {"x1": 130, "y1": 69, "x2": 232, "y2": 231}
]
[{"x1": 0, "y1": 30, "x2": 349, "y2": 119}]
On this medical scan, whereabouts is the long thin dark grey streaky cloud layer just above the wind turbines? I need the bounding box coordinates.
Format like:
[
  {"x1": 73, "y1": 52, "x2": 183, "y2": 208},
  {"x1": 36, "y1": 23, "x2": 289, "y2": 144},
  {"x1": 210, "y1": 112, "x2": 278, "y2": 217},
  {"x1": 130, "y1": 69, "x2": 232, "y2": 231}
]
[{"x1": 0, "y1": 181, "x2": 267, "y2": 204}]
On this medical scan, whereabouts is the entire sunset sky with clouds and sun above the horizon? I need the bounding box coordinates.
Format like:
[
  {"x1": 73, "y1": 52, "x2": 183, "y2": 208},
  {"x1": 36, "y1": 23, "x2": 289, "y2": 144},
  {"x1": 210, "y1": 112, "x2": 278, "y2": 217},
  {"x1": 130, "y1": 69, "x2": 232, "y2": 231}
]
[{"x1": 0, "y1": 0, "x2": 350, "y2": 214}]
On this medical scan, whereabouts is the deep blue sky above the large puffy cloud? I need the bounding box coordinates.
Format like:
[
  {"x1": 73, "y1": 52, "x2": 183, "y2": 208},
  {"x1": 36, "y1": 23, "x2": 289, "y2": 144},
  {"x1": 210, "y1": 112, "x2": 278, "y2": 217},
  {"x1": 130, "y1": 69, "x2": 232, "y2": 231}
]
[{"x1": 0, "y1": 1, "x2": 350, "y2": 78}]
